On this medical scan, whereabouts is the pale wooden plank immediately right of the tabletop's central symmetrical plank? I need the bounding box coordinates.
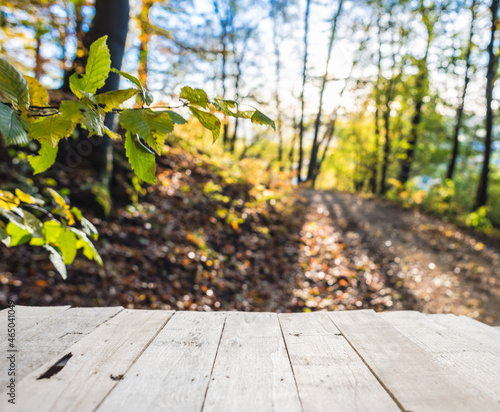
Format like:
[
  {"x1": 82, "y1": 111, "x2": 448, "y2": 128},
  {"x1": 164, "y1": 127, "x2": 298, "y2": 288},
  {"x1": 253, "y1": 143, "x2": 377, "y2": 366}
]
[{"x1": 279, "y1": 312, "x2": 400, "y2": 412}]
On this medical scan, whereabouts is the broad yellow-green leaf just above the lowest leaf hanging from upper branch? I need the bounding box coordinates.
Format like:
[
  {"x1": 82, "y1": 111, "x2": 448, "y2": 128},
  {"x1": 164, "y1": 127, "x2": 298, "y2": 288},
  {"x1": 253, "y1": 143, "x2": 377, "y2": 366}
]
[{"x1": 120, "y1": 109, "x2": 174, "y2": 154}]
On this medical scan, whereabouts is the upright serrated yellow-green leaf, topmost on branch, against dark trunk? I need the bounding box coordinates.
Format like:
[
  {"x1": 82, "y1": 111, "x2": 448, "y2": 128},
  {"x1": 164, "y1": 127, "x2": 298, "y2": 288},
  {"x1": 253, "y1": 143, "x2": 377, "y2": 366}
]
[{"x1": 69, "y1": 36, "x2": 111, "y2": 98}]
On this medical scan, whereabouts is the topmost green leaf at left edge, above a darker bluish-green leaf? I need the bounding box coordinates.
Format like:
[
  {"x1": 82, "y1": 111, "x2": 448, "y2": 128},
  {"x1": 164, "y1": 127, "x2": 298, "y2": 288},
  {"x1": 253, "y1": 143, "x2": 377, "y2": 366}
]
[{"x1": 0, "y1": 58, "x2": 30, "y2": 111}]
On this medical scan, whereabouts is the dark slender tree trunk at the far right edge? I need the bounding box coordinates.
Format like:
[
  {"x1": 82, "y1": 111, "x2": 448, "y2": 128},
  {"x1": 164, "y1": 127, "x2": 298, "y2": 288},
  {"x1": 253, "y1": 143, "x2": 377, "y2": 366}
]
[{"x1": 475, "y1": 0, "x2": 500, "y2": 209}]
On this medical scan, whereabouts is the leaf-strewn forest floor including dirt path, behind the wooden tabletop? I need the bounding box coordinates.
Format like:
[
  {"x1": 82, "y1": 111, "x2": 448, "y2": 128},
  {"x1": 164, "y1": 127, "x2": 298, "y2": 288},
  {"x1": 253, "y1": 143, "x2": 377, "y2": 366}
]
[{"x1": 0, "y1": 148, "x2": 500, "y2": 324}]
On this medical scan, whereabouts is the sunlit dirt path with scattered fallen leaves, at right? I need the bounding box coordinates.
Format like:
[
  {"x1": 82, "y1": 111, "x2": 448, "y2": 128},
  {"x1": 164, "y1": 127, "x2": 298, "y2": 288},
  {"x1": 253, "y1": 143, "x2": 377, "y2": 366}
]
[{"x1": 302, "y1": 190, "x2": 500, "y2": 325}]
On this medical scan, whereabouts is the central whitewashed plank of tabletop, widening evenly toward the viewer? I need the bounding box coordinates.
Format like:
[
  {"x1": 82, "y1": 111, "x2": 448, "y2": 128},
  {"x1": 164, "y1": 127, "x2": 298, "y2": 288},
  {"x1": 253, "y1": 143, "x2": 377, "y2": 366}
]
[{"x1": 203, "y1": 312, "x2": 302, "y2": 412}]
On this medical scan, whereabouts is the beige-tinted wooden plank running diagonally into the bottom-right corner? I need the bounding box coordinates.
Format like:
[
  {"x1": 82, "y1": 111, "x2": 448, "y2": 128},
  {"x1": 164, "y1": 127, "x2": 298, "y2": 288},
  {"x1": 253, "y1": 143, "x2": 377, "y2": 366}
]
[{"x1": 328, "y1": 310, "x2": 500, "y2": 412}]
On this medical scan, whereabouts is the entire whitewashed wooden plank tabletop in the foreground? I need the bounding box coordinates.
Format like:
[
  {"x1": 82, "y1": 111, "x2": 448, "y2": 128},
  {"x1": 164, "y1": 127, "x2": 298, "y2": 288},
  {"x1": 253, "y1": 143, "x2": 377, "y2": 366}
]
[{"x1": 0, "y1": 306, "x2": 500, "y2": 412}]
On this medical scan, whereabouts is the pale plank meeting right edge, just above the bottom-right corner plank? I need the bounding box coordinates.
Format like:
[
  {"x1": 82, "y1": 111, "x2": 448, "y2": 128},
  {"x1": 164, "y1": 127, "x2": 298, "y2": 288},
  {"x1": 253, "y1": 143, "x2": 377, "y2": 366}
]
[{"x1": 379, "y1": 312, "x2": 500, "y2": 400}]
